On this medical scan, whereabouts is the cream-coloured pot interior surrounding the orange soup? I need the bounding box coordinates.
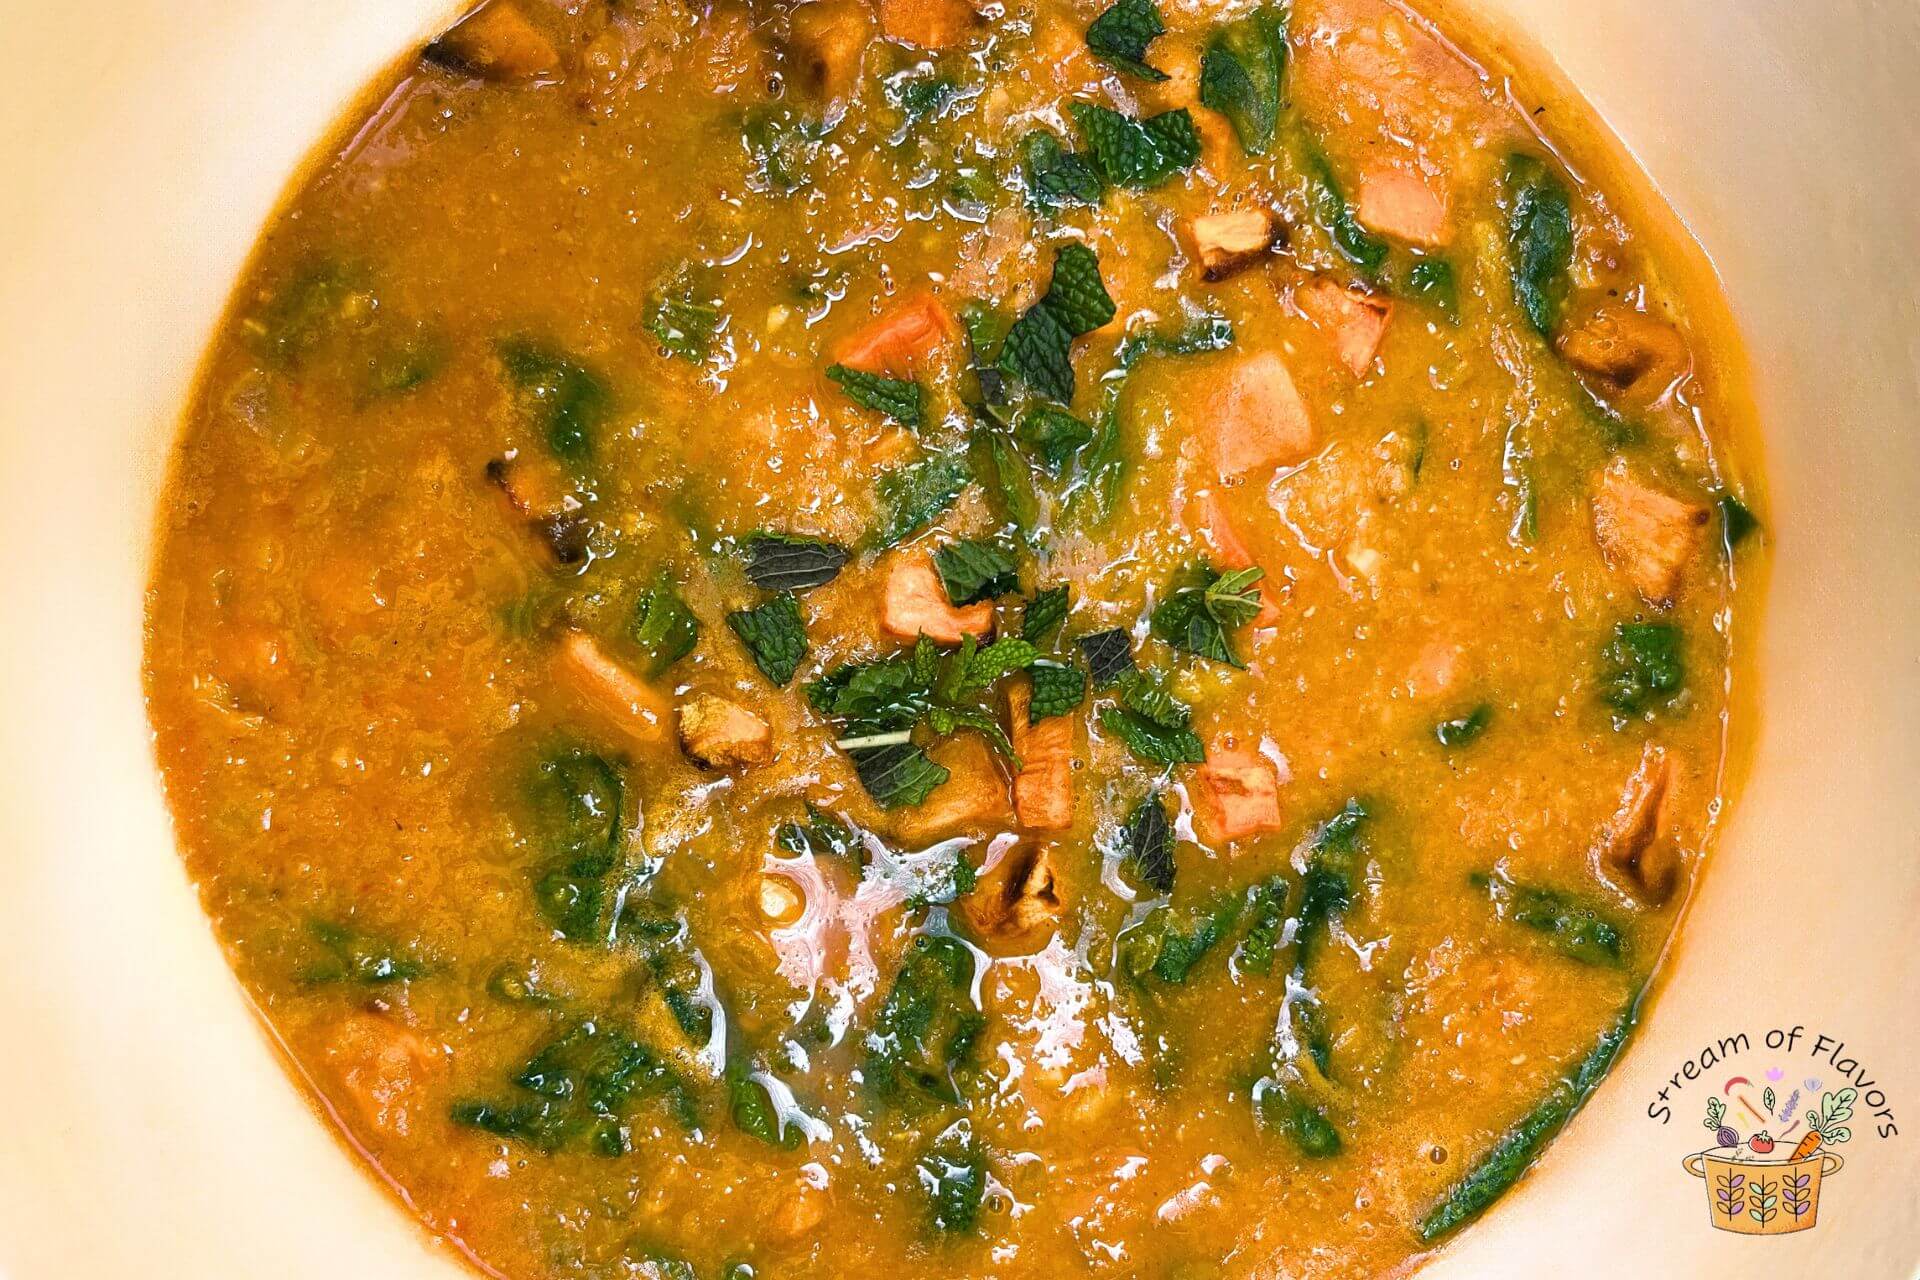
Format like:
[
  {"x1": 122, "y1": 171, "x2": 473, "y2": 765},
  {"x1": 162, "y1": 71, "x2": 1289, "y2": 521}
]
[{"x1": 0, "y1": 0, "x2": 1920, "y2": 1280}]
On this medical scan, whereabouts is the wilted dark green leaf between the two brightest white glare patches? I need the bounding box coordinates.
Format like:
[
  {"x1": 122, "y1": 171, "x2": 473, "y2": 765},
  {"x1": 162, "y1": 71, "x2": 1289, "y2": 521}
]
[{"x1": 864, "y1": 935, "x2": 987, "y2": 1103}]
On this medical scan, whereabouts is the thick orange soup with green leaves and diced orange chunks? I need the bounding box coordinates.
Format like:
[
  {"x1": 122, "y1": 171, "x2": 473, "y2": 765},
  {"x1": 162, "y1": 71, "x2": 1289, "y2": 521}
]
[{"x1": 148, "y1": 0, "x2": 1763, "y2": 1280}]
